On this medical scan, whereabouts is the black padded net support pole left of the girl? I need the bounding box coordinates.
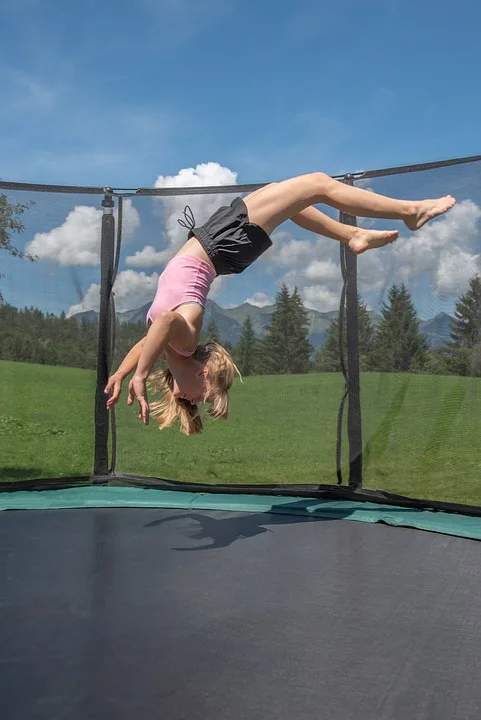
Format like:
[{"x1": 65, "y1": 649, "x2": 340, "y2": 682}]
[{"x1": 94, "y1": 189, "x2": 115, "y2": 477}]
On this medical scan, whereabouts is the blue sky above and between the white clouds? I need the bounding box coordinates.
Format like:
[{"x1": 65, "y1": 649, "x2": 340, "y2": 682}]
[{"x1": 0, "y1": 0, "x2": 481, "y2": 320}]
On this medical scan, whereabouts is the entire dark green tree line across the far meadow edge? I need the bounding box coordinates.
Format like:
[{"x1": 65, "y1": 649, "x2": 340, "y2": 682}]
[{"x1": 0, "y1": 275, "x2": 481, "y2": 376}]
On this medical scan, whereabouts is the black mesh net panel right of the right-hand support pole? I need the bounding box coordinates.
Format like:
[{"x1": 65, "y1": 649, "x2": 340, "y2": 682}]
[{"x1": 348, "y1": 162, "x2": 481, "y2": 505}]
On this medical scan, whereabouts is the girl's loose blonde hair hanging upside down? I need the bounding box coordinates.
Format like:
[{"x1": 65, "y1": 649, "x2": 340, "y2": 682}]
[{"x1": 149, "y1": 342, "x2": 242, "y2": 435}]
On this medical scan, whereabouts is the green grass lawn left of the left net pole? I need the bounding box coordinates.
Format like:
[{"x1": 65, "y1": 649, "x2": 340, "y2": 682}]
[{"x1": 0, "y1": 361, "x2": 95, "y2": 481}]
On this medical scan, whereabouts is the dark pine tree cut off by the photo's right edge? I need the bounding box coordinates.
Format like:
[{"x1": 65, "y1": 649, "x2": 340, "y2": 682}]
[{"x1": 445, "y1": 275, "x2": 481, "y2": 376}]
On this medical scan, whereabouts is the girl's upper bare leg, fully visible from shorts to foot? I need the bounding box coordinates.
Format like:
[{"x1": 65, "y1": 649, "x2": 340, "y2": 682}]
[{"x1": 244, "y1": 173, "x2": 456, "y2": 234}]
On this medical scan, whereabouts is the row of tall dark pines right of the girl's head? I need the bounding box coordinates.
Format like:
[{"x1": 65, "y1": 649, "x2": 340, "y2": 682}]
[{"x1": 224, "y1": 275, "x2": 481, "y2": 376}]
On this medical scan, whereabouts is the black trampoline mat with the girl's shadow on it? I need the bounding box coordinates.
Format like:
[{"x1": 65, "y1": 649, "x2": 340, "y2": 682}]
[{"x1": 0, "y1": 508, "x2": 481, "y2": 720}]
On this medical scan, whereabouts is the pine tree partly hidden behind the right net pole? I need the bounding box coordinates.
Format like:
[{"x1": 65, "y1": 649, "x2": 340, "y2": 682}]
[{"x1": 314, "y1": 295, "x2": 374, "y2": 372}]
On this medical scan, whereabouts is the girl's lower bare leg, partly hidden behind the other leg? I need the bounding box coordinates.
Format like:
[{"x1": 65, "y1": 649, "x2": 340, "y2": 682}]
[{"x1": 291, "y1": 207, "x2": 399, "y2": 255}]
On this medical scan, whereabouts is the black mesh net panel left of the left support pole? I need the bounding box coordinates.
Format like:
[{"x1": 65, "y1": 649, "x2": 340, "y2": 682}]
[{"x1": 0, "y1": 190, "x2": 102, "y2": 481}]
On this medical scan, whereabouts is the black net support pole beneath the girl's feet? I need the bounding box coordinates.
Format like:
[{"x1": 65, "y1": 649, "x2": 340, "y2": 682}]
[{"x1": 340, "y1": 175, "x2": 362, "y2": 490}]
